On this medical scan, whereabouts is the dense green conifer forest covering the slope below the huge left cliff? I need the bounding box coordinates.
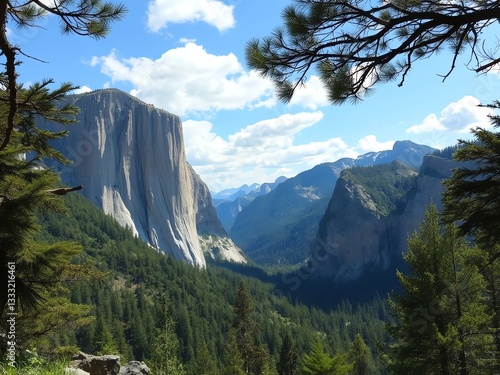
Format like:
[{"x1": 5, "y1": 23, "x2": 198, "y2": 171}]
[{"x1": 34, "y1": 194, "x2": 389, "y2": 374}]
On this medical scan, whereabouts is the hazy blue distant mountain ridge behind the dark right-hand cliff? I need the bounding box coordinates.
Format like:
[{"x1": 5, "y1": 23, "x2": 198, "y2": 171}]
[{"x1": 229, "y1": 141, "x2": 435, "y2": 265}]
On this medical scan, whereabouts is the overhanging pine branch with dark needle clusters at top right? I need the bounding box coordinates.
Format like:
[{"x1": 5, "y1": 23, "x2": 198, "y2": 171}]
[{"x1": 246, "y1": 0, "x2": 500, "y2": 103}]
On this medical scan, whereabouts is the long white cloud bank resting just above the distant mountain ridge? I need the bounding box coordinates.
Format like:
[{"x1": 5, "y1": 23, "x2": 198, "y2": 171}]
[{"x1": 184, "y1": 111, "x2": 394, "y2": 191}]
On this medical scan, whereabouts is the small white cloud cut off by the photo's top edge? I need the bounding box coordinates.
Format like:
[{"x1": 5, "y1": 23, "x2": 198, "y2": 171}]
[{"x1": 147, "y1": 0, "x2": 235, "y2": 32}]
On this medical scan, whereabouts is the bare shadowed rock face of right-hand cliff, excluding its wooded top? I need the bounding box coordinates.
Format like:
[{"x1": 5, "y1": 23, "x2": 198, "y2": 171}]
[{"x1": 311, "y1": 155, "x2": 458, "y2": 282}]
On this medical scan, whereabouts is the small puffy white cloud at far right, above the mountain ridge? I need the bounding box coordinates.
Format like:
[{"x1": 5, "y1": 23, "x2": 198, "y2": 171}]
[{"x1": 406, "y1": 96, "x2": 492, "y2": 134}]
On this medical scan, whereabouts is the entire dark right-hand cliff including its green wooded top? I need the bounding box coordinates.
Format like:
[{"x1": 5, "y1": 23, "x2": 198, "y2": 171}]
[{"x1": 311, "y1": 155, "x2": 458, "y2": 282}]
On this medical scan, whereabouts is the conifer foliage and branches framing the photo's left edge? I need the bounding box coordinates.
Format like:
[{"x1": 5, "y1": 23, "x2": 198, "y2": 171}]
[{"x1": 0, "y1": 0, "x2": 124, "y2": 358}]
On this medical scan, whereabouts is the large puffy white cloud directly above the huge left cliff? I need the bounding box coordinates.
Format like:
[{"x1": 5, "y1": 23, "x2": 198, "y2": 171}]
[{"x1": 91, "y1": 42, "x2": 276, "y2": 116}]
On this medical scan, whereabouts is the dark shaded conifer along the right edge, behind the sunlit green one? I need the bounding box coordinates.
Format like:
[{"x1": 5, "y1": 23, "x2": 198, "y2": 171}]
[{"x1": 444, "y1": 101, "x2": 500, "y2": 367}]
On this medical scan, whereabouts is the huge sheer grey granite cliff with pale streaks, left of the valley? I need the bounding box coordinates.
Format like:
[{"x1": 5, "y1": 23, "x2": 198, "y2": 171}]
[{"x1": 45, "y1": 90, "x2": 205, "y2": 267}]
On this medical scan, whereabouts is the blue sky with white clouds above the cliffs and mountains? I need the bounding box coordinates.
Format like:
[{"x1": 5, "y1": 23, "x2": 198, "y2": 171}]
[{"x1": 8, "y1": 0, "x2": 500, "y2": 192}]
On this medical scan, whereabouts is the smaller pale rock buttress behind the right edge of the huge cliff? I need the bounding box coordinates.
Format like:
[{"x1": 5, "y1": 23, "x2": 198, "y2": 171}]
[{"x1": 188, "y1": 164, "x2": 247, "y2": 263}]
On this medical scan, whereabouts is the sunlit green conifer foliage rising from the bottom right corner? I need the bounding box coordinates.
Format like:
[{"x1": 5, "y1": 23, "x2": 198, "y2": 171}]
[{"x1": 389, "y1": 206, "x2": 493, "y2": 375}]
